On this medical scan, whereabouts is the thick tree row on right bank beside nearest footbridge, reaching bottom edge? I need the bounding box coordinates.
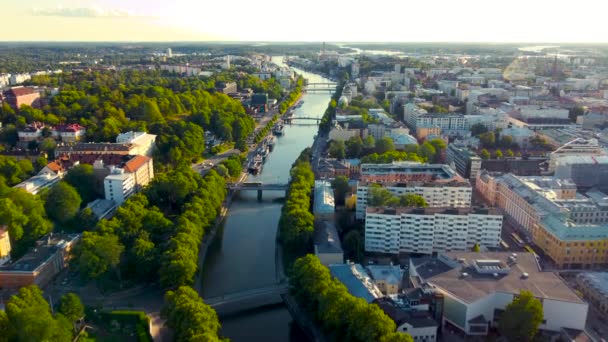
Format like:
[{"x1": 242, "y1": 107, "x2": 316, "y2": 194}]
[{"x1": 289, "y1": 254, "x2": 413, "y2": 342}]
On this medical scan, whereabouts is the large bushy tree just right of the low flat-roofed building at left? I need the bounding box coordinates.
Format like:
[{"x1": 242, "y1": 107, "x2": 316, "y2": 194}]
[{"x1": 77, "y1": 232, "x2": 125, "y2": 278}]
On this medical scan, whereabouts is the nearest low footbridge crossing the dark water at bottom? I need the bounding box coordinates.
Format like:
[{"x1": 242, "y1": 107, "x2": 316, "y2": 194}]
[{"x1": 204, "y1": 283, "x2": 289, "y2": 317}]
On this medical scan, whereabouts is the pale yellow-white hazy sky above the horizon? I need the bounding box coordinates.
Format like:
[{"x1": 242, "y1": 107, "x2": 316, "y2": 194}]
[{"x1": 0, "y1": 0, "x2": 608, "y2": 43}]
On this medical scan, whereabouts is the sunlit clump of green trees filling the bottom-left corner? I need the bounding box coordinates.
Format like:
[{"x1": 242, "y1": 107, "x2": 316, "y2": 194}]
[{"x1": 0, "y1": 285, "x2": 84, "y2": 342}]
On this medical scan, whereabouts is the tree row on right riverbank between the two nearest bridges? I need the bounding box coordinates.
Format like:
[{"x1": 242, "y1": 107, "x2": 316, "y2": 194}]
[{"x1": 279, "y1": 148, "x2": 315, "y2": 255}]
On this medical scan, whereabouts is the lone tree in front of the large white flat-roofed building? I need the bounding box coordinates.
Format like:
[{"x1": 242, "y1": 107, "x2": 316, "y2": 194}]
[{"x1": 498, "y1": 290, "x2": 543, "y2": 341}]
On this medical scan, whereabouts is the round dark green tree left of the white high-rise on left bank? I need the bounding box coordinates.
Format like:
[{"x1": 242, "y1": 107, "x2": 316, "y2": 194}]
[{"x1": 44, "y1": 181, "x2": 82, "y2": 224}]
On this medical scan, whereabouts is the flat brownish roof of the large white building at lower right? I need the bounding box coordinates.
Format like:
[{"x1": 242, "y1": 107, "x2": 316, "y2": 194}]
[{"x1": 411, "y1": 252, "x2": 584, "y2": 304}]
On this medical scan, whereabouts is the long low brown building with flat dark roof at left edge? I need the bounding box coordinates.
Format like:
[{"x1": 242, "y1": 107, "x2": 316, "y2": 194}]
[{"x1": 0, "y1": 234, "x2": 80, "y2": 289}]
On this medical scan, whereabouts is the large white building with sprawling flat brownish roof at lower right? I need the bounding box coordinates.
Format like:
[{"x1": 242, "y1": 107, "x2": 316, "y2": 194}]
[{"x1": 409, "y1": 252, "x2": 588, "y2": 336}]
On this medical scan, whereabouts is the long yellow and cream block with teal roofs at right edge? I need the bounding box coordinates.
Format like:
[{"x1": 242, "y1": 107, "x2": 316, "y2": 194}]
[{"x1": 475, "y1": 172, "x2": 608, "y2": 268}]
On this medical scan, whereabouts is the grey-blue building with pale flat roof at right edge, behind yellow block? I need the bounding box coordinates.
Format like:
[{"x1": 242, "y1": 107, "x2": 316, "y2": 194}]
[{"x1": 555, "y1": 155, "x2": 608, "y2": 191}]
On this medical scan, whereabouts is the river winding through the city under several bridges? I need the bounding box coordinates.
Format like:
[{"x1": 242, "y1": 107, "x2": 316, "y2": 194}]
[{"x1": 202, "y1": 56, "x2": 331, "y2": 342}]
